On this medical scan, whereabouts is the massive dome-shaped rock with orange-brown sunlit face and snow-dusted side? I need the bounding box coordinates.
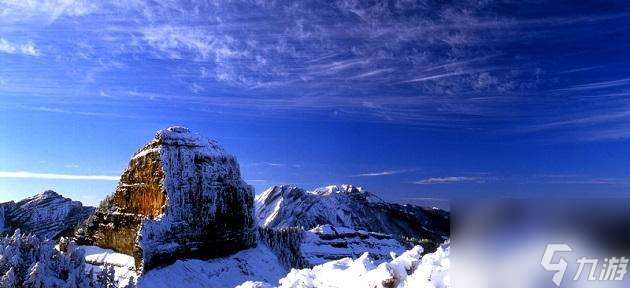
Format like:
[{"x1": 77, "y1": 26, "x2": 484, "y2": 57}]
[{"x1": 75, "y1": 127, "x2": 256, "y2": 271}]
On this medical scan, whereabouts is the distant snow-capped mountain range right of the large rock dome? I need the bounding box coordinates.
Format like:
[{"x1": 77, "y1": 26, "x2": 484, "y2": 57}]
[{"x1": 255, "y1": 185, "x2": 450, "y2": 244}]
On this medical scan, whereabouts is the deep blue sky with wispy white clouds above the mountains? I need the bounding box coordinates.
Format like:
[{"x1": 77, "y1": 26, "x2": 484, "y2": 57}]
[{"x1": 0, "y1": 0, "x2": 630, "y2": 205}]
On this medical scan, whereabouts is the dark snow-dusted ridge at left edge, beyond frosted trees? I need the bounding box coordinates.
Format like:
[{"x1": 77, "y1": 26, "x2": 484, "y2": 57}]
[{"x1": 0, "y1": 190, "x2": 94, "y2": 239}]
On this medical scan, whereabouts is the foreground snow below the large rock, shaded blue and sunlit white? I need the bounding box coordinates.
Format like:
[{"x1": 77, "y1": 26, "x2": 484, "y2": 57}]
[{"x1": 82, "y1": 244, "x2": 451, "y2": 288}]
